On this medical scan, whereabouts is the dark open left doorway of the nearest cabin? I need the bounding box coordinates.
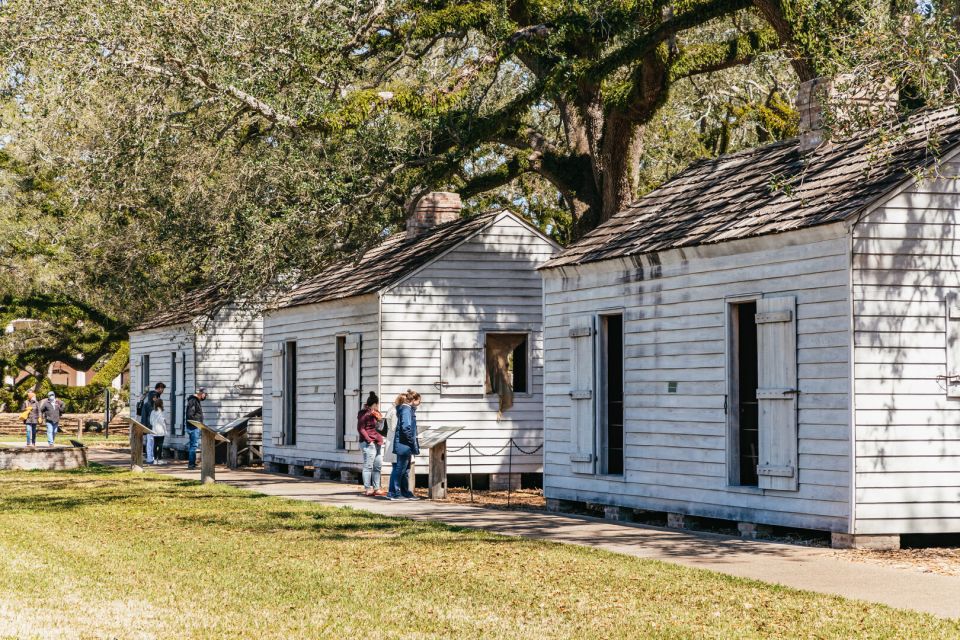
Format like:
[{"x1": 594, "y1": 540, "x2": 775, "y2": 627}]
[{"x1": 600, "y1": 314, "x2": 623, "y2": 475}]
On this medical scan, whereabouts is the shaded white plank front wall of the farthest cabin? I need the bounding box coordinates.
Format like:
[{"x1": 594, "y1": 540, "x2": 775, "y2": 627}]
[{"x1": 130, "y1": 323, "x2": 194, "y2": 446}]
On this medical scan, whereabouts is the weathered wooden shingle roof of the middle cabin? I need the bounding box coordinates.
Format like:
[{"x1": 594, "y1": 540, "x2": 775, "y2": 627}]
[{"x1": 276, "y1": 211, "x2": 503, "y2": 308}]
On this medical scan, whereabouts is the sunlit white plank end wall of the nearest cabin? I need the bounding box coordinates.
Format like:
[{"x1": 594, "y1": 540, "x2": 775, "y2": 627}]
[{"x1": 853, "y1": 162, "x2": 960, "y2": 534}]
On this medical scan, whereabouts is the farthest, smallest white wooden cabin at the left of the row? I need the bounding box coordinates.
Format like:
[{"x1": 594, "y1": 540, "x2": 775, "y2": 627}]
[{"x1": 130, "y1": 289, "x2": 263, "y2": 452}]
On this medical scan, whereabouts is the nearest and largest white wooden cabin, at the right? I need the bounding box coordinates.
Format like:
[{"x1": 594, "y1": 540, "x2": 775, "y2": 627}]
[{"x1": 541, "y1": 108, "x2": 960, "y2": 546}]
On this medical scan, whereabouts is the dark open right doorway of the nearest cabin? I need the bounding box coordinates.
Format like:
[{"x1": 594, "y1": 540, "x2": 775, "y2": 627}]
[{"x1": 728, "y1": 300, "x2": 760, "y2": 487}]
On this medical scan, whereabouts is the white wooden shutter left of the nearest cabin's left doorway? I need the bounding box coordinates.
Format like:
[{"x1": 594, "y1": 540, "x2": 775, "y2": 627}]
[{"x1": 569, "y1": 315, "x2": 596, "y2": 473}]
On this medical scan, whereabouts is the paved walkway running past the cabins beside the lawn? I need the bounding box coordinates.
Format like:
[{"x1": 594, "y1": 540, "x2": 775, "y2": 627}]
[{"x1": 88, "y1": 449, "x2": 960, "y2": 618}]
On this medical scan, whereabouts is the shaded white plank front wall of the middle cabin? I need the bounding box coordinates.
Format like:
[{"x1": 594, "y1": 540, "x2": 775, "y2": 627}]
[{"x1": 263, "y1": 294, "x2": 380, "y2": 468}]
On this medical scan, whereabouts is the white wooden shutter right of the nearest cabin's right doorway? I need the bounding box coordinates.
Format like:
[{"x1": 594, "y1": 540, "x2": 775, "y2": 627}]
[{"x1": 756, "y1": 296, "x2": 799, "y2": 491}]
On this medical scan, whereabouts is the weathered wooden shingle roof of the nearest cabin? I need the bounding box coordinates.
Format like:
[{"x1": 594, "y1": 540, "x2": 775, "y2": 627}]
[{"x1": 541, "y1": 107, "x2": 960, "y2": 269}]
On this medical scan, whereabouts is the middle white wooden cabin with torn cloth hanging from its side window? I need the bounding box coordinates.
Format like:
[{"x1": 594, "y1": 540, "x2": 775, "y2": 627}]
[{"x1": 263, "y1": 193, "x2": 557, "y2": 485}]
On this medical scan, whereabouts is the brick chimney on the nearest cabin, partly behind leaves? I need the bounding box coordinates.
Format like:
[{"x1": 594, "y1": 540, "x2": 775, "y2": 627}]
[{"x1": 797, "y1": 74, "x2": 898, "y2": 153}]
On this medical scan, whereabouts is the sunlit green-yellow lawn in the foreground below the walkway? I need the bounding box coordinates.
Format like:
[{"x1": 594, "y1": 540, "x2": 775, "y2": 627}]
[{"x1": 0, "y1": 467, "x2": 960, "y2": 639}]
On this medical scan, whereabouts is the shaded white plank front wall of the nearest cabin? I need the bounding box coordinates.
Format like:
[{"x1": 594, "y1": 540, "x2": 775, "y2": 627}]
[{"x1": 544, "y1": 225, "x2": 851, "y2": 531}]
